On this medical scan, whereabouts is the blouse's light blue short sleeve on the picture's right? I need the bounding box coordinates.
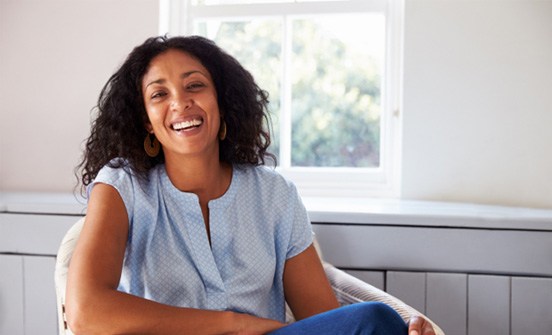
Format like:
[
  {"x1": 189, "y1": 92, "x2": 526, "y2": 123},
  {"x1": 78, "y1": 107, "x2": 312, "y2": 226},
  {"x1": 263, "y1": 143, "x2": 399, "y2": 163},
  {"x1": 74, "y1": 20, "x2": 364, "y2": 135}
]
[{"x1": 286, "y1": 185, "x2": 313, "y2": 259}]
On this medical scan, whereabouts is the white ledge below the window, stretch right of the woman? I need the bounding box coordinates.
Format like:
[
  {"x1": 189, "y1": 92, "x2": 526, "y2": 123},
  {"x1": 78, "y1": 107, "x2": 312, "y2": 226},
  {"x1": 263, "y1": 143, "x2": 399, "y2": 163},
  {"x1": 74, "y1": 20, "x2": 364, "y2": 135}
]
[{"x1": 303, "y1": 197, "x2": 552, "y2": 231}]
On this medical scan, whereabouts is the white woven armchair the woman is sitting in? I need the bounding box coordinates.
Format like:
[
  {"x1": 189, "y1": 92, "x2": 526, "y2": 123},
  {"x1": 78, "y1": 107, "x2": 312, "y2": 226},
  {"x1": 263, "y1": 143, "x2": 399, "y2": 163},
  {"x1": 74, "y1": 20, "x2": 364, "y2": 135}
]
[{"x1": 55, "y1": 218, "x2": 444, "y2": 335}]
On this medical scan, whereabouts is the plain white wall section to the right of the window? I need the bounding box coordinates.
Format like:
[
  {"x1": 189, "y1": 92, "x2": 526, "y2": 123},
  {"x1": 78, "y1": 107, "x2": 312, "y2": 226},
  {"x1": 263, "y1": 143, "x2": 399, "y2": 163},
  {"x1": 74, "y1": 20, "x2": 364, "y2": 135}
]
[{"x1": 402, "y1": 0, "x2": 552, "y2": 208}]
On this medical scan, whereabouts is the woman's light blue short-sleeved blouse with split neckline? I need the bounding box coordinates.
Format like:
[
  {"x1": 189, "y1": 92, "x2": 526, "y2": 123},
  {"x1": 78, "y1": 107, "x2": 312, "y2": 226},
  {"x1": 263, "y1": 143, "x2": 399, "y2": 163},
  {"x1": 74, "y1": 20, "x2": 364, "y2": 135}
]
[{"x1": 89, "y1": 165, "x2": 312, "y2": 322}]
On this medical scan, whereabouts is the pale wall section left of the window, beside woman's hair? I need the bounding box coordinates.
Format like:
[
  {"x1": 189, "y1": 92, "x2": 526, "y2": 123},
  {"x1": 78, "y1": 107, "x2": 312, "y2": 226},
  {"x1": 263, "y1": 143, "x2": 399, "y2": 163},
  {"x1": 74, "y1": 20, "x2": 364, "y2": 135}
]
[{"x1": 0, "y1": 0, "x2": 159, "y2": 192}]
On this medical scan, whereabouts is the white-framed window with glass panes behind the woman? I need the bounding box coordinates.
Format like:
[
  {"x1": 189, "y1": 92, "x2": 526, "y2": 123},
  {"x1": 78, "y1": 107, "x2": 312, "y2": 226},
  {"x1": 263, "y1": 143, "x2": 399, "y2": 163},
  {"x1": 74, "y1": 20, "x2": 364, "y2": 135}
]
[{"x1": 160, "y1": 0, "x2": 402, "y2": 196}]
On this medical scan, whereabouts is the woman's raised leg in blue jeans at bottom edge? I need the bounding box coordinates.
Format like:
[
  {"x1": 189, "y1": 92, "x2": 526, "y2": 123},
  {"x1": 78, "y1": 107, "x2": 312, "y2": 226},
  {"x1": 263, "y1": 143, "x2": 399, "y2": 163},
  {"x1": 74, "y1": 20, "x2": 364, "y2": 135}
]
[{"x1": 269, "y1": 302, "x2": 408, "y2": 335}]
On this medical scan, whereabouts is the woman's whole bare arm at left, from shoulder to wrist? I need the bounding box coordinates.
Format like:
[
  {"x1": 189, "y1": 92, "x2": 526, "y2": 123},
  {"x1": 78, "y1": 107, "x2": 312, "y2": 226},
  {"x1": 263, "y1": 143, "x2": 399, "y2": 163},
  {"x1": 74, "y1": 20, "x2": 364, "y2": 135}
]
[{"x1": 66, "y1": 184, "x2": 282, "y2": 334}]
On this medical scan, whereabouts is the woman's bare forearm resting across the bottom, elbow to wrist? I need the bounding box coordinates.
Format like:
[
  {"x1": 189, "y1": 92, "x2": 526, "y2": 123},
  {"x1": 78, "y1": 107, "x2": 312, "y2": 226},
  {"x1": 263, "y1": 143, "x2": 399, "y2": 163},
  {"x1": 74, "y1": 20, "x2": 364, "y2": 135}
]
[{"x1": 66, "y1": 290, "x2": 283, "y2": 334}]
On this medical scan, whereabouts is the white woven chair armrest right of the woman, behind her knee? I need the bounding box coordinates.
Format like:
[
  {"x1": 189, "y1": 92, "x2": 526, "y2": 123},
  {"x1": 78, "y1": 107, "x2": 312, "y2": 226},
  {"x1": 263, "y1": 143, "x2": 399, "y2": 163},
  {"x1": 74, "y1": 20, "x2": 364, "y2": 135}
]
[{"x1": 324, "y1": 263, "x2": 445, "y2": 335}]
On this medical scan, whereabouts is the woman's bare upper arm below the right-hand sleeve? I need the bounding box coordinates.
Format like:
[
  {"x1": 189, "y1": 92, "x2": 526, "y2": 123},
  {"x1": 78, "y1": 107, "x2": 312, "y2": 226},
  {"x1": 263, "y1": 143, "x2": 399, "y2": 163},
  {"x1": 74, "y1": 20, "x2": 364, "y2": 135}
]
[{"x1": 284, "y1": 245, "x2": 339, "y2": 320}]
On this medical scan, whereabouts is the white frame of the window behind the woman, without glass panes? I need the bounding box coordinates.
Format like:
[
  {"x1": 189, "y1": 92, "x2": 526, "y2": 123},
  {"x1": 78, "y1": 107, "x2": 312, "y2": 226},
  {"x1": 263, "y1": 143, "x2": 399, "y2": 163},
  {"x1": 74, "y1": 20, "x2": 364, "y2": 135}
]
[{"x1": 159, "y1": 0, "x2": 404, "y2": 197}]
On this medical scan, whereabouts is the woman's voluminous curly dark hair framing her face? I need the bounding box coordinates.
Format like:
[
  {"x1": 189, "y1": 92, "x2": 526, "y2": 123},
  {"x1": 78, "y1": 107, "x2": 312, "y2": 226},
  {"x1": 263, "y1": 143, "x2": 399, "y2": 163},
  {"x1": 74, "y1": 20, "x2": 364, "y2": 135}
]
[{"x1": 77, "y1": 36, "x2": 276, "y2": 186}]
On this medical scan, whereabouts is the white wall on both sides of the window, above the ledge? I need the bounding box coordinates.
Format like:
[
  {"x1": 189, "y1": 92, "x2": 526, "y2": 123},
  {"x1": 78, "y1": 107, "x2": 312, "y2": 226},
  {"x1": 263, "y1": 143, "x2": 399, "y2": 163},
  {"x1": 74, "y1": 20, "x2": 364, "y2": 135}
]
[{"x1": 0, "y1": 0, "x2": 552, "y2": 208}]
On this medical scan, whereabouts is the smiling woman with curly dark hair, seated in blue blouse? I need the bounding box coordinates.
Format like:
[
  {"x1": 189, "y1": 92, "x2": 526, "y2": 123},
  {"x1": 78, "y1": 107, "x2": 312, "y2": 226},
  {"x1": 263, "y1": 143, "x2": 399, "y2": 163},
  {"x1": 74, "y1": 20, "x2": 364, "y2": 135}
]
[{"x1": 66, "y1": 37, "x2": 433, "y2": 335}]
